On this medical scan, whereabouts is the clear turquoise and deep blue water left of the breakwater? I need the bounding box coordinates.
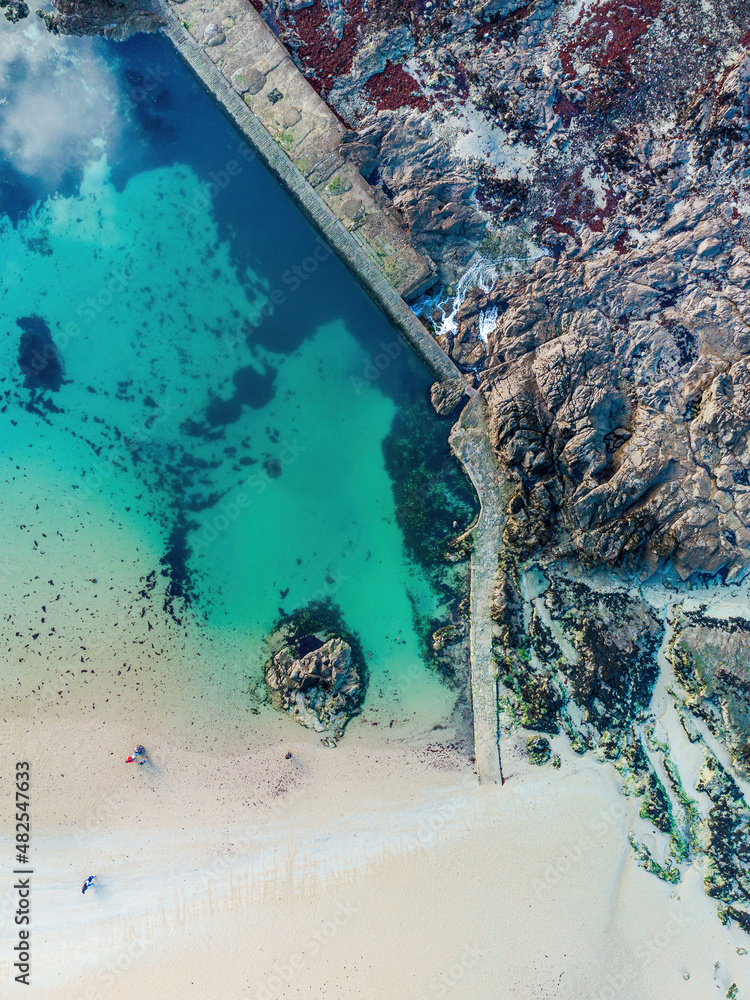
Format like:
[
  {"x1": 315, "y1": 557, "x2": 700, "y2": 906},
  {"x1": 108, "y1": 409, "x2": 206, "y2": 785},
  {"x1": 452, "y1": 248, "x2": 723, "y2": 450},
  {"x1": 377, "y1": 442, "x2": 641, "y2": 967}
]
[{"x1": 0, "y1": 21, "x2": 471, "y2": 728}]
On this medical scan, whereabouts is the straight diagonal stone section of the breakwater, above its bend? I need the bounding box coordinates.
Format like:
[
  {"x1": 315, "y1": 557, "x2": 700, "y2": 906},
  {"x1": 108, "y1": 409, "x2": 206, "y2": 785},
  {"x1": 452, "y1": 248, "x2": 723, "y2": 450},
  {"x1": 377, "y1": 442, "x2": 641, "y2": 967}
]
[{"x1": 157, "y1": 0, "x2": 468, "y2": 387}]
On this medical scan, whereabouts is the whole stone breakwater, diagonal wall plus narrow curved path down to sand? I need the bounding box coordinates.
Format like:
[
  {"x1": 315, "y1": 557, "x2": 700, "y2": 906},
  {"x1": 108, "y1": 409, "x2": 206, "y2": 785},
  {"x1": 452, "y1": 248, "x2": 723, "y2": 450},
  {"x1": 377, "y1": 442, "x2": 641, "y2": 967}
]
[{"x1": 157, "y1": 0, "x2": 502, "y2": 783}]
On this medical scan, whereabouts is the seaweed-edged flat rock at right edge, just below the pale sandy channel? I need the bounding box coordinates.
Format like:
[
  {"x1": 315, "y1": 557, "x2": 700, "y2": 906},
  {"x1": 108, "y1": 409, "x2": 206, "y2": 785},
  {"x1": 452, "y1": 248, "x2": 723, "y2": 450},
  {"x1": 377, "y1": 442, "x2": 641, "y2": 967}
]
[{"x1": 670, "y1": 612, "x2": 750, "y2": 777}]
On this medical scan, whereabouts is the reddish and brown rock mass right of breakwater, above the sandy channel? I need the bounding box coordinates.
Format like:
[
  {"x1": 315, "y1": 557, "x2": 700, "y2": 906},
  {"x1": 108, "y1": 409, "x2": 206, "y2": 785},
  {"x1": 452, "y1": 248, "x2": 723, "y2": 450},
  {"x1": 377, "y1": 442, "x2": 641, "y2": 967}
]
[{"x1": 241, "y1": 0, "x2": 750, "y2": 577}]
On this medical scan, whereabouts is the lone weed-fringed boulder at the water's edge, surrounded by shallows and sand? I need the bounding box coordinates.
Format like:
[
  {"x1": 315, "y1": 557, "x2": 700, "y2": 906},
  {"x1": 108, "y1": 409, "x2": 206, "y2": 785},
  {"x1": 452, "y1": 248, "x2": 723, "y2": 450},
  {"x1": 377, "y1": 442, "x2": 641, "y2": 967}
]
[{"x1": 265, "y1": 604, "x2": 366, "y2": 732}]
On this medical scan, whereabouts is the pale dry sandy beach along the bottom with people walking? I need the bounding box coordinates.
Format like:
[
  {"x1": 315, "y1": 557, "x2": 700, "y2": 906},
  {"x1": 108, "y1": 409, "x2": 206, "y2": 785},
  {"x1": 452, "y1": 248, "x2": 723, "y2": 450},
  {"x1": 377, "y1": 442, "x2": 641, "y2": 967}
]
[{"x1": 5, "y1": 696, "x2": 750, "y2": 1000}]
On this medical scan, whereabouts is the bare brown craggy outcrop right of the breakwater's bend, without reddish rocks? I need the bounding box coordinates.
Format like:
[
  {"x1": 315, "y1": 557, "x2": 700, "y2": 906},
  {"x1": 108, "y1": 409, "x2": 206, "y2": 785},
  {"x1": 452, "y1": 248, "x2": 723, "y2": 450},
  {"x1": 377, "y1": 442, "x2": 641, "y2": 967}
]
[{"x1": 452, "y1": 55, "x2": 750, "y2": 579}]
